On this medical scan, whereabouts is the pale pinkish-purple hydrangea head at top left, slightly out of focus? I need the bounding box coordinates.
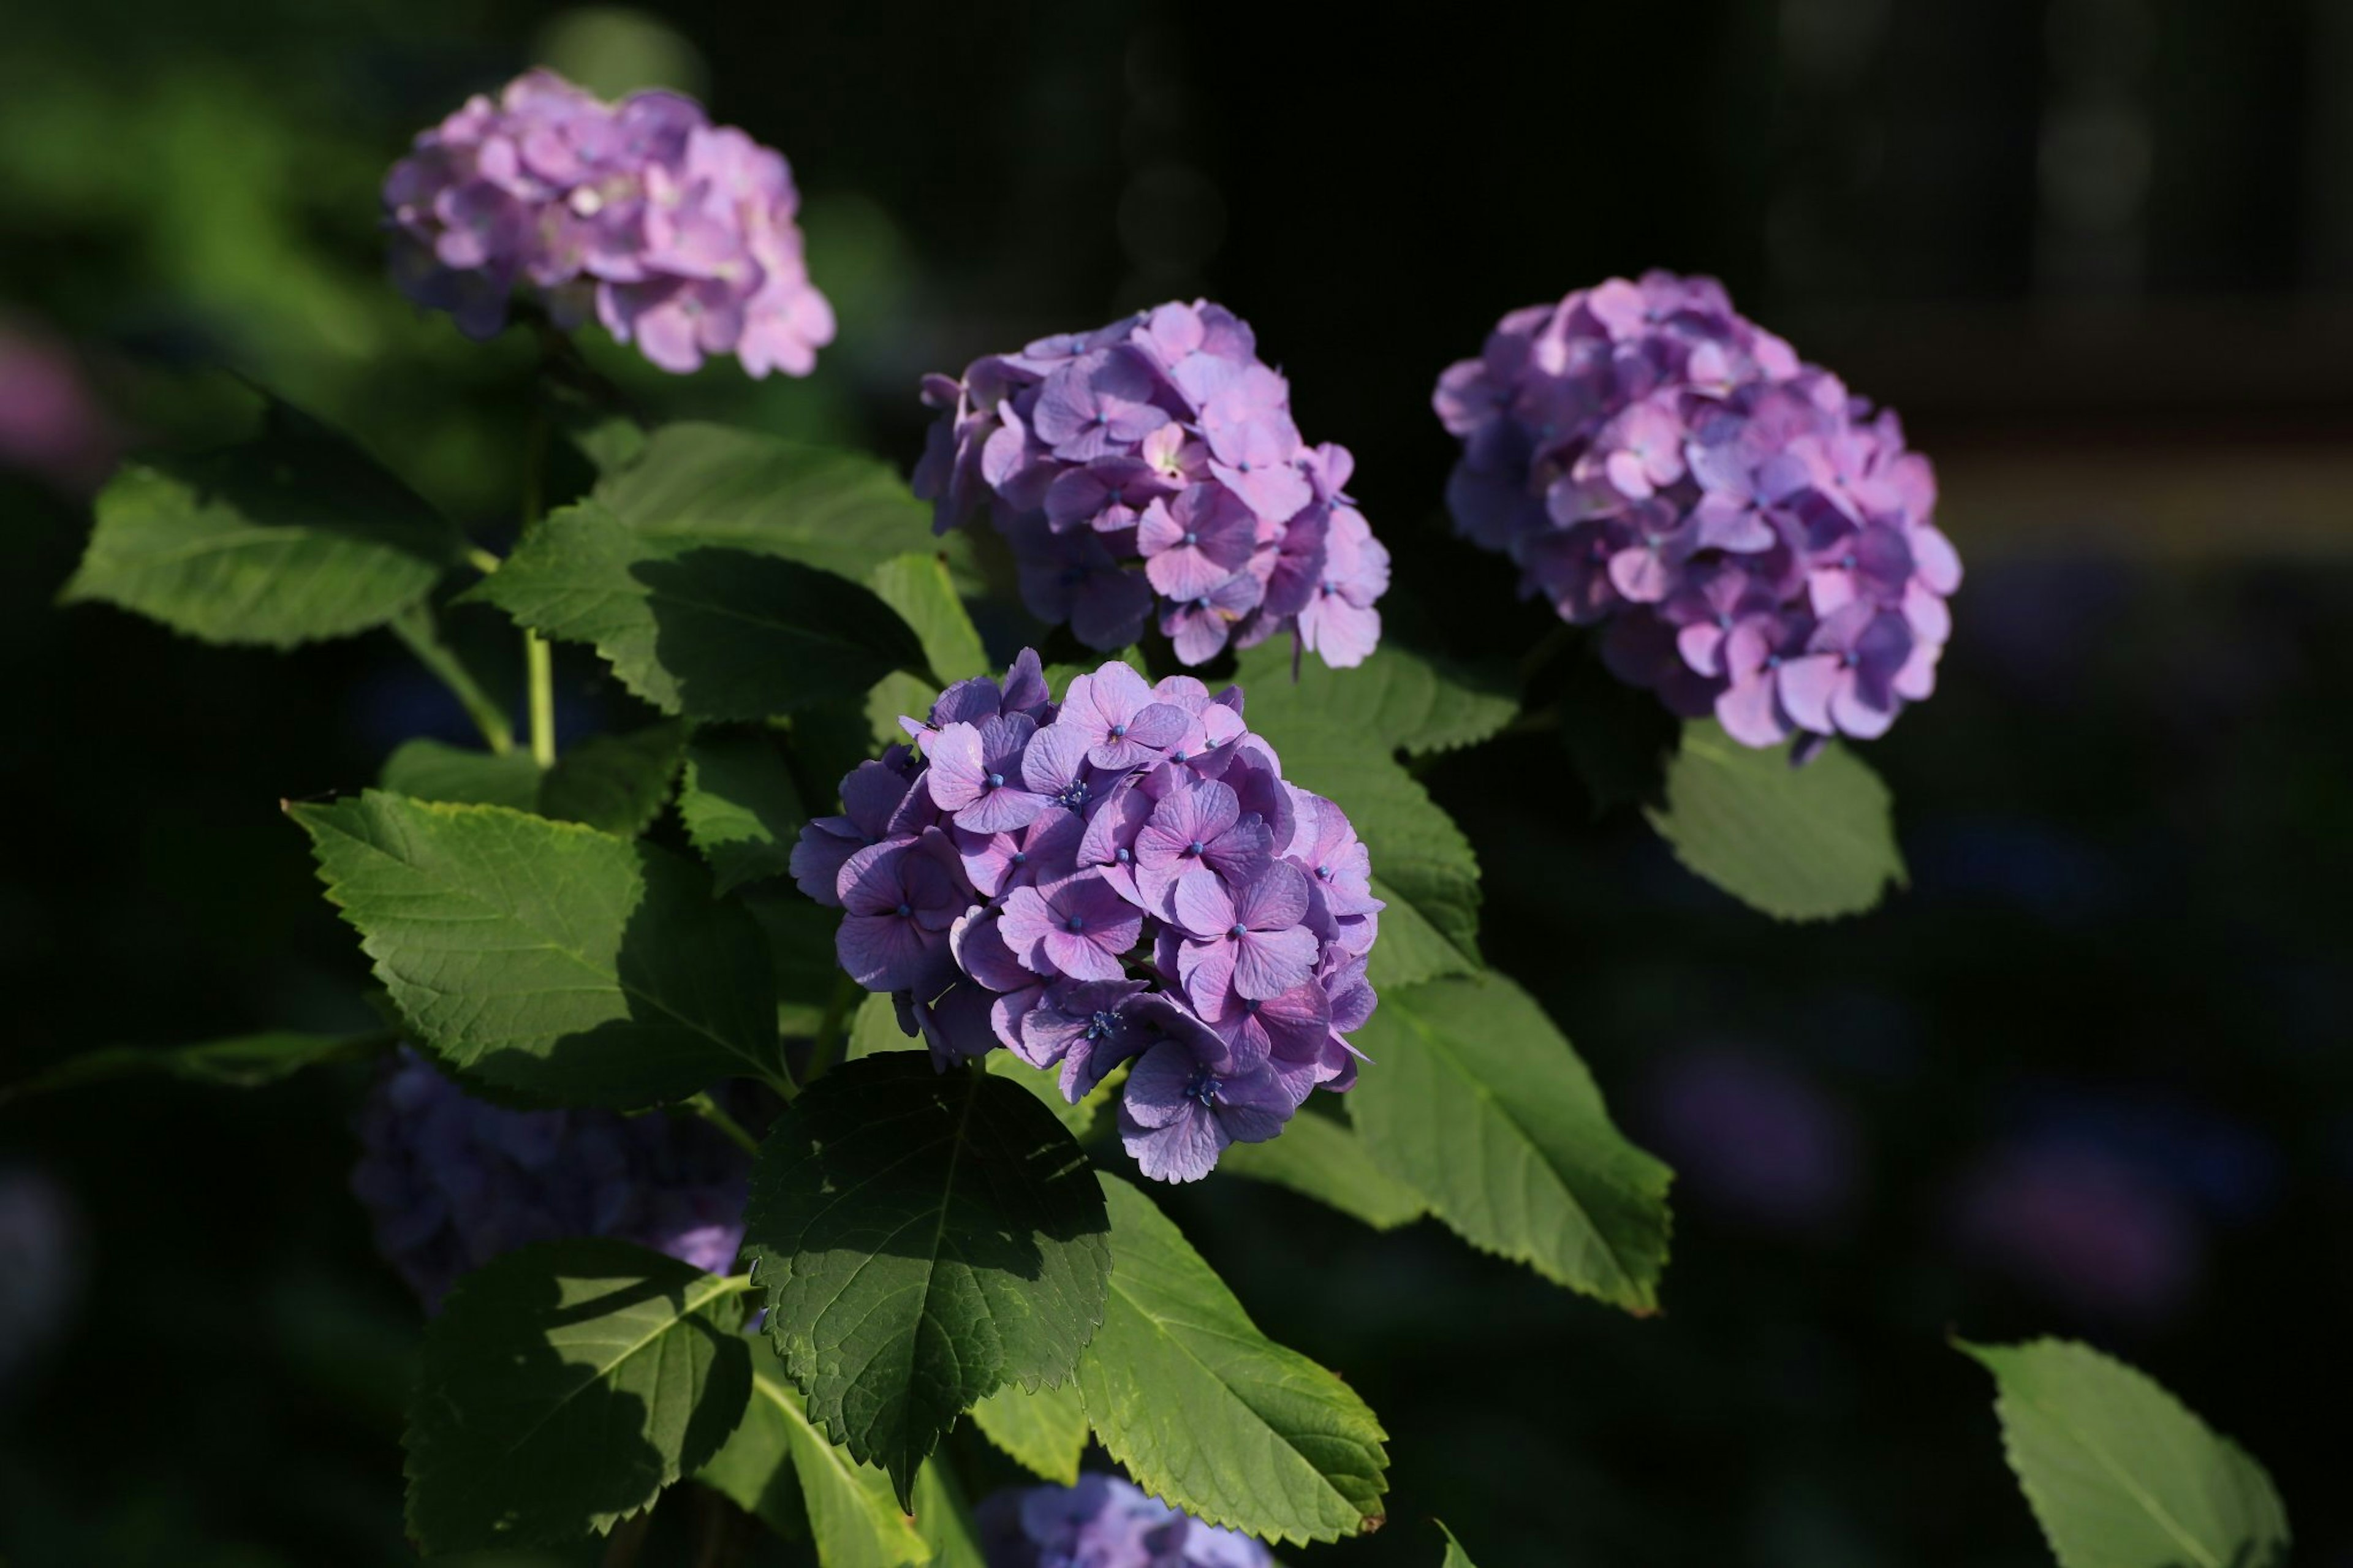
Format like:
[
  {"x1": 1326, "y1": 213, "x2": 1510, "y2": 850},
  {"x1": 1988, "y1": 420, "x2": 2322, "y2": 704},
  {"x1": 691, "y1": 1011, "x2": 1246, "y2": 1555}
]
[{"x1": 384, "y1": 70, "x2": 833, "y2": 377}]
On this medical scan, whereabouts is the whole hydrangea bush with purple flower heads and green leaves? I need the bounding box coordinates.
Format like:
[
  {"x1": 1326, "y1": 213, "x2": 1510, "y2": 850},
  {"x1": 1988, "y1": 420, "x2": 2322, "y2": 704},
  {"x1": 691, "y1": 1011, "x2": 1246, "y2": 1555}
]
[{"x1": 23, "y1": 61, "x2": 2285, "y2": 1568}]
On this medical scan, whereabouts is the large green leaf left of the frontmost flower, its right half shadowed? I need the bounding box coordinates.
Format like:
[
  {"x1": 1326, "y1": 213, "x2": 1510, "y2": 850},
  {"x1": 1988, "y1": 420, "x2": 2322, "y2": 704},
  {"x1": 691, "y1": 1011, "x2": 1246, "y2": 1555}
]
[{"x1": 287, "y1": 791, "x2": 776, "y2": 1107}]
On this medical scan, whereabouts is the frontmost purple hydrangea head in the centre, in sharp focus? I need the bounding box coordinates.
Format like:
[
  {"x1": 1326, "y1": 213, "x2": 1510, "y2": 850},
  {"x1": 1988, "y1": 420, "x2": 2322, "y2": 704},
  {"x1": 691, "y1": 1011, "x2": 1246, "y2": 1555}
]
[{"x1": 790, "y1": 650, "x2": 1381, "y2": 1182}]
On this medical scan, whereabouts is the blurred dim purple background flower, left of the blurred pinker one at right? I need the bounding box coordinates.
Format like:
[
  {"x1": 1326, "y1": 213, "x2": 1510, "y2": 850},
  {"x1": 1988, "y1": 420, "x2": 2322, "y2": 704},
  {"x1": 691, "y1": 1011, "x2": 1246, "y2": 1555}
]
[{"x1": 1640, "y1": 1045, "x2": 1863, "y2": 1232}]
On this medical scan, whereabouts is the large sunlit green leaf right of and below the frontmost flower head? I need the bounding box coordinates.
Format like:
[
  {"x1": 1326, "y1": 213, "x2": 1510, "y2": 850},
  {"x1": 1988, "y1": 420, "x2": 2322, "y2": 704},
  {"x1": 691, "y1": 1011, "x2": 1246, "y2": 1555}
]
[{"x1": 1348, "y1": 972, "x2": 1670, "y2": 1311}]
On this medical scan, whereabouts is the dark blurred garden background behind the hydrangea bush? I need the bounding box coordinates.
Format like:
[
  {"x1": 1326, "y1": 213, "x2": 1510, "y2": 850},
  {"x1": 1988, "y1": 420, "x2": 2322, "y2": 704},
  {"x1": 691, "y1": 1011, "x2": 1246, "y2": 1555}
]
[{"x1": 0, "y1": 0, "x2": 2353, "y2": 1568}]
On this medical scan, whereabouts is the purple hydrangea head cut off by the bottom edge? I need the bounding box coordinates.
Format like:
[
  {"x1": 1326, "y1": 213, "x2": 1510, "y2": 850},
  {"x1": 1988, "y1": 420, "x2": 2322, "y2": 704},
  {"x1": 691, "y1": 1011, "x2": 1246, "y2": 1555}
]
[{"x1": 974, "y1": 1471, "x2": 1273, "y2": 1568}]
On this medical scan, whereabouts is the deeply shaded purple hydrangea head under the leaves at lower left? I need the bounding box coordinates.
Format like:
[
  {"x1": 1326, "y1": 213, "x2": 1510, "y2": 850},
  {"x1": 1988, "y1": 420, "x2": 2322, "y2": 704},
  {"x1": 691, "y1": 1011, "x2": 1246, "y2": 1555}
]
[{"x1": 350, "y1": 1048, "x2": 751, "y2": 1311}]
